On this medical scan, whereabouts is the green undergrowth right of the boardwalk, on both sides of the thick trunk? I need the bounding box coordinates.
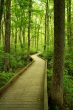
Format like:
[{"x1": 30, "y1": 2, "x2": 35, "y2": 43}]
[{"x1": 41, "y1": 52, "x2": 73, "y2": 110}]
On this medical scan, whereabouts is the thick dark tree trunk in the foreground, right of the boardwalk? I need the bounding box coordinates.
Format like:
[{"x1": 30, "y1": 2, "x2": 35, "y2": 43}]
[{"x1": 51, "y1": 0, "x2": 65, "y2": 106}]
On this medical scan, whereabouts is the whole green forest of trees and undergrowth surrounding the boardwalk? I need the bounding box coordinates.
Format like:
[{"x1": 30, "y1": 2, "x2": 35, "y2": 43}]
[{"x1": 0, "y1": 0, "x2": 73, "y2": 110}]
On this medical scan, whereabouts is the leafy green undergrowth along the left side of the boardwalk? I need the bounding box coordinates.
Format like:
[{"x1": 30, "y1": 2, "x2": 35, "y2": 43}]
[{"x1": 0, "y1": 48, "x2": 34, "y2": 88}]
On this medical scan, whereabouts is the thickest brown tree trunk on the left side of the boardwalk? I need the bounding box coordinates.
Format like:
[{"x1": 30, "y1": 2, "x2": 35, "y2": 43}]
[{"x1": 4, "y1": 0, "x2": 11, "y2": 71}]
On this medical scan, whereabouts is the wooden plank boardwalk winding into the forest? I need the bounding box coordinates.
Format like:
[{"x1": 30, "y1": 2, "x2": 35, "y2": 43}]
[{"x1": 0, "y1": 55, "x2": 45, "y2": 110}]
